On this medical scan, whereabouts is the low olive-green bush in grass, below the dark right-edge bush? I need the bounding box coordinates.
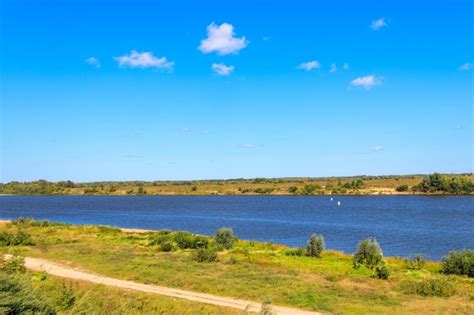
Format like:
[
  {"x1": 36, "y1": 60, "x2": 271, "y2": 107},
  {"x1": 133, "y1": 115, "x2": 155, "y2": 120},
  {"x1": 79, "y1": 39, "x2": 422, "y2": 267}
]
[{"x1": 401, "y1": 279, "x2": 456, "y2": 297}]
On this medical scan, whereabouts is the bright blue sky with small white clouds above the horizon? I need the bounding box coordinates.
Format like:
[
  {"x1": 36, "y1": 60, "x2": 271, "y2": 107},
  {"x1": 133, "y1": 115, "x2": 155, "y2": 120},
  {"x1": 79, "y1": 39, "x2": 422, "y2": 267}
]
[{"x1": 0, "y1": 0, "x2": 474, "y2": 182}]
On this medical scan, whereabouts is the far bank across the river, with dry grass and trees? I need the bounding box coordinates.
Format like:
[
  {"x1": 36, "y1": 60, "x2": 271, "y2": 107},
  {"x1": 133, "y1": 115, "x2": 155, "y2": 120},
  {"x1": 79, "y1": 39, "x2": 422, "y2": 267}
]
[{"x1": 0, "y1": 173, "x2": 474, "y2": 196}]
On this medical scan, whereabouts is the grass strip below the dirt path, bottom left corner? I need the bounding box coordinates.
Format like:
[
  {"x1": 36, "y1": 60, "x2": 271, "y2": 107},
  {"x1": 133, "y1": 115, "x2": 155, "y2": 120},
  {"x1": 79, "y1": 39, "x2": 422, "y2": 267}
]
[{"x1": 0, "y1": 271, "x2": 241, "y2": 315}]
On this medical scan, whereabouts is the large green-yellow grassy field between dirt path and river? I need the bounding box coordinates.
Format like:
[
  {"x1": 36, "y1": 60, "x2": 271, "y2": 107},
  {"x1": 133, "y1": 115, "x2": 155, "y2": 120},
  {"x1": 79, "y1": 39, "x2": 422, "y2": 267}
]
[{"x1": 0, "y1": 220, "x2": 474, "y2": 314}]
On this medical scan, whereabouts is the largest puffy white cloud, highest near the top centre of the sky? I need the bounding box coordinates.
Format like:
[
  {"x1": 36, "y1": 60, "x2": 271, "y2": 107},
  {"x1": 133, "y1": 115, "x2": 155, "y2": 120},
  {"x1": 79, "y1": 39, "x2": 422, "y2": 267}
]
[{"x1": 198, "y1": 22, "x2": 249, "y2": 55}]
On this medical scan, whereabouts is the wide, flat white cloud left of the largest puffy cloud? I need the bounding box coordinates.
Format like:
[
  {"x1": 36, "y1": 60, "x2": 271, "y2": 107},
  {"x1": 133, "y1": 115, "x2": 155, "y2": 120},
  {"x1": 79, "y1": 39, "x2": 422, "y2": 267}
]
[{"x1": 115, "y1": 50, "x2": 174, "y2": 70}]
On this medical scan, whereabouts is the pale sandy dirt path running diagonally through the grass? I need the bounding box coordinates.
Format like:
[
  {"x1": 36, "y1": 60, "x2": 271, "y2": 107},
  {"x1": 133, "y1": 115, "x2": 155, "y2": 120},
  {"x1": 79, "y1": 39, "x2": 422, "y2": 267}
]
[{"x1": 20, "y1": 257, "x2": 321, "y2": 315}]
